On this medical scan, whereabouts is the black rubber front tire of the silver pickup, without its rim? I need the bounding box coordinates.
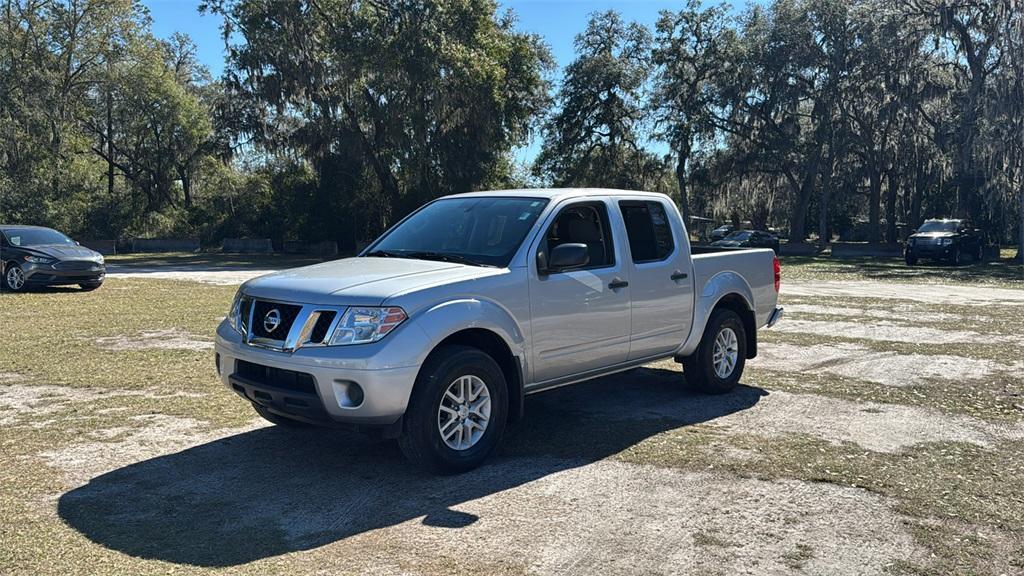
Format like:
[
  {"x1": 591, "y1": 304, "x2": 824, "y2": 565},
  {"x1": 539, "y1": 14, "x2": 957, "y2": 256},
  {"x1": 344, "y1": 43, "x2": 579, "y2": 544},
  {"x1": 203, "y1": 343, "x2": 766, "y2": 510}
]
[{"x1": 398, "y1": 345, "x2": 508, "y2": 474}]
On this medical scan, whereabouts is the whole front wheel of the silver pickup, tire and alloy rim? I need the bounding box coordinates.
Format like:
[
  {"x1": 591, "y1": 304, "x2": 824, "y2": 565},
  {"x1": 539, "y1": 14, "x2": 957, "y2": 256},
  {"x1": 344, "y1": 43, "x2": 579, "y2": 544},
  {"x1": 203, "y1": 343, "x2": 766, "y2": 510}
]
[{"x1": 398, "y1": 345, "x2": 508, "y2": 474}]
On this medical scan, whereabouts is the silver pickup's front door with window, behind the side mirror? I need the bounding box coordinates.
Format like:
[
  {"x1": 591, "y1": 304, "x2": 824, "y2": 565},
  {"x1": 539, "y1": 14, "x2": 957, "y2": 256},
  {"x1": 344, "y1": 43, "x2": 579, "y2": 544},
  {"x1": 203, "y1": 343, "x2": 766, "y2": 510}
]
[{"x1": 529, "y1": 200, "x2": 630, "y2": 383}]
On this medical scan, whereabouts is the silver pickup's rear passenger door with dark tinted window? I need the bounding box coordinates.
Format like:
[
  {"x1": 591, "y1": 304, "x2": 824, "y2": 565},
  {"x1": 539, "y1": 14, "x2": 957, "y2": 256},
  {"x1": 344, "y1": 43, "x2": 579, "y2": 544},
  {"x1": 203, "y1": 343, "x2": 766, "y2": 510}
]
[{"x1": 618, "y1": 199, "x2": 693, "y2": 360}]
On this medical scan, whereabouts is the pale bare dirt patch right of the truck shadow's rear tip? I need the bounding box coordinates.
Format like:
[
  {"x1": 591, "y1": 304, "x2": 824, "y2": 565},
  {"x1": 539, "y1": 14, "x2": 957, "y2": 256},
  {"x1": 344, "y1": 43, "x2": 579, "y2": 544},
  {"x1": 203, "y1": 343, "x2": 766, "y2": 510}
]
[{"x1": 711, "y1": 392, "x2": 1024, "y2": 453}]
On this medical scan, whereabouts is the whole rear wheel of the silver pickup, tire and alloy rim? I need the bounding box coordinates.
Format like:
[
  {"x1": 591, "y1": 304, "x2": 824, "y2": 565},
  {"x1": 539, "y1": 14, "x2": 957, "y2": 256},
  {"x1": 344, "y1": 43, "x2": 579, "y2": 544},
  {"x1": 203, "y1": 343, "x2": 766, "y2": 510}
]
[{"x1": 683, "y1": 308, "x2": 746, "y2": 394}]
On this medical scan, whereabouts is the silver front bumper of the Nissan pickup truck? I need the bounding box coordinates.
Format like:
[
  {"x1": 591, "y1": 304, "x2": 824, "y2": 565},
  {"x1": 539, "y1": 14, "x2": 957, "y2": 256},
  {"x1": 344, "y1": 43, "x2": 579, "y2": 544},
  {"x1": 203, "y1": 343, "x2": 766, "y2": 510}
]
[{"x1": 215, "y1": 322, "x2": 430, "y2": 427}]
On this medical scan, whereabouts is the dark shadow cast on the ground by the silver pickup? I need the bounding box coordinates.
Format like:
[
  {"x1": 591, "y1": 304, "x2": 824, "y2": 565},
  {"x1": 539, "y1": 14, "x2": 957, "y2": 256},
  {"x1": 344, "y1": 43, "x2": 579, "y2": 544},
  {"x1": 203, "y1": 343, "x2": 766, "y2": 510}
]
[{"x1": 58, "y1": 368, "x2": 767, "y2": 567}]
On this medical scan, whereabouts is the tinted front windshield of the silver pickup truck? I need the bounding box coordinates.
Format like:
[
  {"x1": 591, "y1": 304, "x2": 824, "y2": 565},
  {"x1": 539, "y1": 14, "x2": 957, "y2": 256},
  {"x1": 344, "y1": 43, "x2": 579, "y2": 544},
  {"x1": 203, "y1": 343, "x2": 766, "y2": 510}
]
[{"x1": 364, "y1": 197, "x2": 548, "y2": 266}]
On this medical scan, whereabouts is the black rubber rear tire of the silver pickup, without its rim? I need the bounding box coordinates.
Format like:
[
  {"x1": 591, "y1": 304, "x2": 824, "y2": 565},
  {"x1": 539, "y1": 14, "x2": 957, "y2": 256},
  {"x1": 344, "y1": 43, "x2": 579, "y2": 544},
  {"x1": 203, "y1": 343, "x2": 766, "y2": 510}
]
[{"x1": 683, "y1": 308, "x2": 746, "y2": 394}]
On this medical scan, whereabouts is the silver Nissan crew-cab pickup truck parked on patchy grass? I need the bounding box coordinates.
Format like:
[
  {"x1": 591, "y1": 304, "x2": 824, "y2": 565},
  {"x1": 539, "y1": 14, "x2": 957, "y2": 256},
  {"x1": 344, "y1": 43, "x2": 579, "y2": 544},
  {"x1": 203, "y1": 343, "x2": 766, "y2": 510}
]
[{"x1": 216, "y1": 189, "x2": 781, "y2": 471}]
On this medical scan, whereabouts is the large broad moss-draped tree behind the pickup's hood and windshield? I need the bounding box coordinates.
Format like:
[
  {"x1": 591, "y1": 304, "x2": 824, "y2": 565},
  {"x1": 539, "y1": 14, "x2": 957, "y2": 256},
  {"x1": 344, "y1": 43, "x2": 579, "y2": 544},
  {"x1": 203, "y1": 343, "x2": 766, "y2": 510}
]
[{"x1": 204, "y1": 0, "x2": 550, "y2": 237}]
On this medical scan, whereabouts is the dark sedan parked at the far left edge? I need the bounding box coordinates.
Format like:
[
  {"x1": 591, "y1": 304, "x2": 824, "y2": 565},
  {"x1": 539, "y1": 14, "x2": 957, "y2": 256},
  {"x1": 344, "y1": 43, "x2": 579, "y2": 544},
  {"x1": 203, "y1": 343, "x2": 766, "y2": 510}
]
[{"x1": 0, "y1": 224, "x2": 106, "y2": 292}]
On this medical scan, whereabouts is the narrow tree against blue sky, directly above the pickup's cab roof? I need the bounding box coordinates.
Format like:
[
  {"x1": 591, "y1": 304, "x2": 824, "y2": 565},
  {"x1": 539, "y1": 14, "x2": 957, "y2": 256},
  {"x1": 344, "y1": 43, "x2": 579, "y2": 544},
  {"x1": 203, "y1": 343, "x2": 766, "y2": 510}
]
[{"x1": 535, "y1": 10, "x2": 664, "y2": 190}]
